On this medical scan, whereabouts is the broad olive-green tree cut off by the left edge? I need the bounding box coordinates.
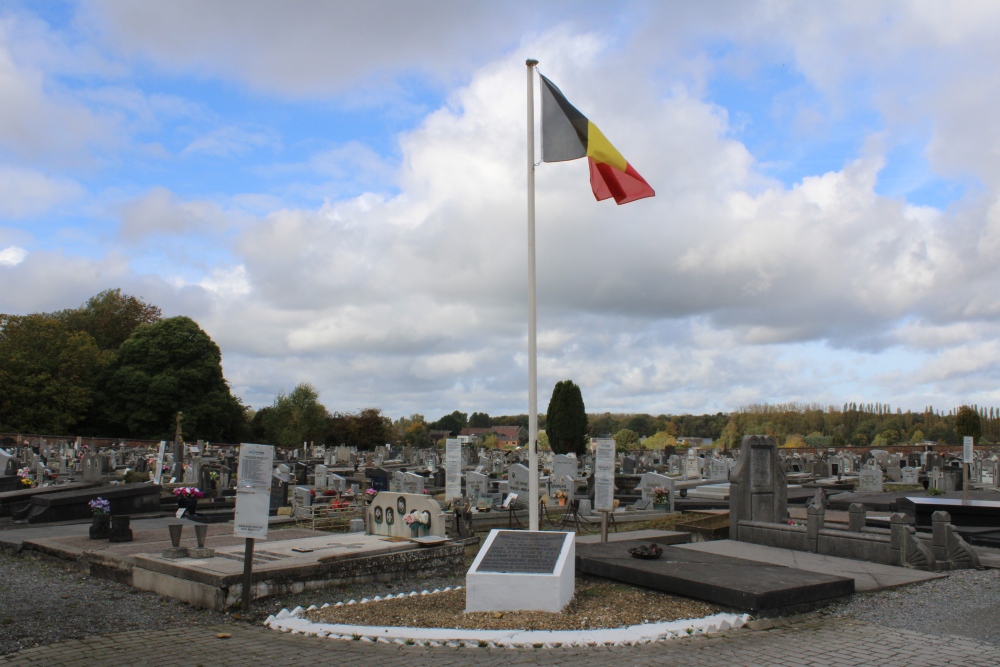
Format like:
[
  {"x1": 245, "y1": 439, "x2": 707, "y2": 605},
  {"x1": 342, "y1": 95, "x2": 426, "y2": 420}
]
[{"x1": 0, "y1": 315, "x2": 101, "y2": 435}]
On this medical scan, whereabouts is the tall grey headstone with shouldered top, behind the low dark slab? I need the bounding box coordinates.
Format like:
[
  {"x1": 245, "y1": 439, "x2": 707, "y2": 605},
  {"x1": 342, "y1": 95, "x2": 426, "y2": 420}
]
[{"x1": 729, "y1": 435, "x2": 788, "y2": 540}]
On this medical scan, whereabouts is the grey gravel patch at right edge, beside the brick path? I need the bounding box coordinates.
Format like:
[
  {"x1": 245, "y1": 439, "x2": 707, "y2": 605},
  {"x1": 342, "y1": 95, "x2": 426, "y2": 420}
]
[{"x1": 829, "y1": 570, "x2": 1000, "y2": 646}]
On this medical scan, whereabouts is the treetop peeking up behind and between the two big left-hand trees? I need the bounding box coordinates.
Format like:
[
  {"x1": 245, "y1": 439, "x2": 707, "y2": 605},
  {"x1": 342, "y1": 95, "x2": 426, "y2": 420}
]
[{"x1": 50, "y1": 287, "x2": 162, "y2": 351}]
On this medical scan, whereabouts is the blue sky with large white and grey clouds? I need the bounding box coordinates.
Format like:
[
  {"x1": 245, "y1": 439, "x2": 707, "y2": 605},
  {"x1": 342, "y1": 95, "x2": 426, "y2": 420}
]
[{"x1": 0, "y1": 0, "x2": 1000, "y2": 419}]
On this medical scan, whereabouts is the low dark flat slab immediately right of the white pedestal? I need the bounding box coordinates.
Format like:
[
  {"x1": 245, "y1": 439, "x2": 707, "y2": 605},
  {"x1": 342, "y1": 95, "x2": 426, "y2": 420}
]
[{"x1": 576, "y1": 540, "x2": 854, "y2": 616}]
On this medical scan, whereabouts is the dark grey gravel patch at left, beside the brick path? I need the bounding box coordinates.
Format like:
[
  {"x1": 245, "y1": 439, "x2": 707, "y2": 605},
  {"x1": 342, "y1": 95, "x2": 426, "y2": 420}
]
[{"x1": 0, "y1": 550, "x2": 232, "y2": 655}]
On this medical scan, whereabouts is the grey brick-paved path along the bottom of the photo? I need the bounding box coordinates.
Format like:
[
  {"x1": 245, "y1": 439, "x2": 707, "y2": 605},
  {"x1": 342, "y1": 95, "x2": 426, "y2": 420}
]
[{"x1": 0, "y1": 617, "x2": 997, "y2": 667}]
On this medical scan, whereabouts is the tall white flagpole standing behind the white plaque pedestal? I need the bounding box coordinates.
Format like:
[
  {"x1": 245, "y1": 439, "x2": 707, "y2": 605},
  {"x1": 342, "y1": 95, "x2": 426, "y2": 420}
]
[{"x1": 525, "y1": 59, "x2": 538, "y2": 530}]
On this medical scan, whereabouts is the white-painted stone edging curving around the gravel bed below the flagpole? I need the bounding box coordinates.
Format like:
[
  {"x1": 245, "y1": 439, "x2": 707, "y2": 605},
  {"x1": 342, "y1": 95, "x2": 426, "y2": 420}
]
[{"x1": 264, "y1": 586, "x2": 750, "y2": 648}]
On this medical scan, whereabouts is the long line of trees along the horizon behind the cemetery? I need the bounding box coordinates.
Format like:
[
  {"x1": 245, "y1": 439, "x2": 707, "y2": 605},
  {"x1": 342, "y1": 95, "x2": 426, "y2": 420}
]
[{"x1": 0, "y1": 304, "x2": 1000, "y2": 453}]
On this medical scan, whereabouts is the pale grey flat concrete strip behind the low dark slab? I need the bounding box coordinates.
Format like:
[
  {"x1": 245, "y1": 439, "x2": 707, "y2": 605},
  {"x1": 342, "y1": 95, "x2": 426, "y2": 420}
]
[{"x1": 677, "y1": 540, "x2": 947, "y2": 592}]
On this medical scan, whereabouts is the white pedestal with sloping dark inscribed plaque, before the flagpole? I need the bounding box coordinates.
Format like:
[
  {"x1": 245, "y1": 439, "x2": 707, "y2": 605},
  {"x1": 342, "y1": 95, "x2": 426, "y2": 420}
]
[{"x1": 465, "y1": 529, "x2": 576, "y2": 613}]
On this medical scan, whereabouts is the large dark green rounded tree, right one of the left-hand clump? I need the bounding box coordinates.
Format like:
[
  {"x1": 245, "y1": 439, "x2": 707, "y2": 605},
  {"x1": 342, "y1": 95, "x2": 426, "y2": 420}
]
[{"x1": 95, "y1": 317, "x2": 247, "y2": 442}]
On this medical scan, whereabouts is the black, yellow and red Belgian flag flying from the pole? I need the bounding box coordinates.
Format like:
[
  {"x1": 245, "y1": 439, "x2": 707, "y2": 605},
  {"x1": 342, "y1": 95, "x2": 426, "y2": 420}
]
[{"x1": 539, "y1": 73, "x2": 656, "y2": 204}]
